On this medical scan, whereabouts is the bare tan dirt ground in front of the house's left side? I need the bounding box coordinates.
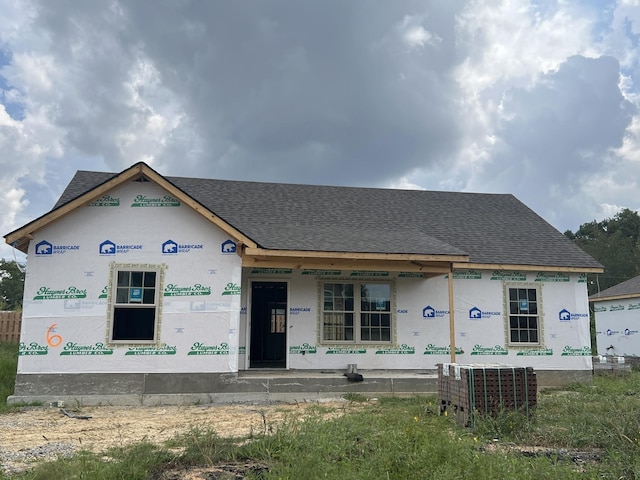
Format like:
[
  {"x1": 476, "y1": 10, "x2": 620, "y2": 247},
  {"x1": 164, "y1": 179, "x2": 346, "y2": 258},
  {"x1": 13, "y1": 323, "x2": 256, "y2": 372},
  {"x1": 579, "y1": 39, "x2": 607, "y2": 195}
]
[{"x1": 0, "y1": 401, "x2": 357, "y2": 480}]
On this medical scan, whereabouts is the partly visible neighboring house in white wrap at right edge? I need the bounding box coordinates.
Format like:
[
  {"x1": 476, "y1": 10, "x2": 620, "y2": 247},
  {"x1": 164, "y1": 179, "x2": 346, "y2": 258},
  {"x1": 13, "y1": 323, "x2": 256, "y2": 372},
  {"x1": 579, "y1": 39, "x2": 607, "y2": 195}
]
[{"x1": 589, "y1": 276, "x2": 640, "y2": 357}]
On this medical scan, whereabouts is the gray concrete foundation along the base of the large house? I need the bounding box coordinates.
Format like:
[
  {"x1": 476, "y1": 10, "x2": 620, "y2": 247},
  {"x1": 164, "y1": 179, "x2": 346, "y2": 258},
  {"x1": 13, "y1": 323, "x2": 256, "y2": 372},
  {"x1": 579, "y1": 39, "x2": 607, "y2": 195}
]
[{"x1": 7, "y1": 370, "x2": 593, "y2": 405}]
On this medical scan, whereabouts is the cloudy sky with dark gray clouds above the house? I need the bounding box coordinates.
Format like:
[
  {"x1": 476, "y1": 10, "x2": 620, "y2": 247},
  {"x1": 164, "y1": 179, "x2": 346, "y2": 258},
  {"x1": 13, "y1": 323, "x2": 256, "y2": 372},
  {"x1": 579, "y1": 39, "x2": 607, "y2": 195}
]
[{"x1": 0, "y1": 0, "x2": 640, "y2": 259}]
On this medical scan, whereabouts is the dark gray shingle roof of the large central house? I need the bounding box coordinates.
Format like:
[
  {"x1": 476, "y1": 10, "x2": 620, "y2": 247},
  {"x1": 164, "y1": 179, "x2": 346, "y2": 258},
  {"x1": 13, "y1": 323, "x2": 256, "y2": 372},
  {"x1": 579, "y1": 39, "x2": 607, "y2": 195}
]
[{"x1": 54, "y1": 171, "x2": 601, "y2": 268}]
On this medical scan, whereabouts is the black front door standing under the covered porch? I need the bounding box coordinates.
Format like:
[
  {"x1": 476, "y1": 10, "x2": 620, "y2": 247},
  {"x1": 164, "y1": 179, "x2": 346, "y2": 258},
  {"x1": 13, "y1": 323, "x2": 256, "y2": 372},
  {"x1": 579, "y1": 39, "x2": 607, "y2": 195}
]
[{"x1": 249, "y1": 282, "x2": 287, "y2": 368}]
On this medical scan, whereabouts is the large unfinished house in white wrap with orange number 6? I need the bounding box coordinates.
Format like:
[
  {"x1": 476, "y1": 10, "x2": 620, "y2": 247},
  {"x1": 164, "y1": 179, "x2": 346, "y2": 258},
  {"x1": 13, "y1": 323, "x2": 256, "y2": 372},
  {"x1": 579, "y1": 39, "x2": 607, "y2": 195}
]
[{"x1": 5, "y1": 163, "x2": 602, "y2": 403}]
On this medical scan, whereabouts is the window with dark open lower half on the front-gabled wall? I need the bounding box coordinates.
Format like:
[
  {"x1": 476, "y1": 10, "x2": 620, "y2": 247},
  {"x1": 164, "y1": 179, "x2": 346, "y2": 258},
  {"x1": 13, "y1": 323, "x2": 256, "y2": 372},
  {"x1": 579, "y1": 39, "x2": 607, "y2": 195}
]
[{"x1": 109, "y1": 265, "x2": 161, "y2": 343}]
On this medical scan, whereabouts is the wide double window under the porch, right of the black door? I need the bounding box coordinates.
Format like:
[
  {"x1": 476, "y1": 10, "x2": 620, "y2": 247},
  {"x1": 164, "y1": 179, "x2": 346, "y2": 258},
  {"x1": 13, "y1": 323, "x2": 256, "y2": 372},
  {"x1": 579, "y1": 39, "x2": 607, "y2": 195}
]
[{"x1": 322, "y1": 283, "x2": 392, "y2": 343}]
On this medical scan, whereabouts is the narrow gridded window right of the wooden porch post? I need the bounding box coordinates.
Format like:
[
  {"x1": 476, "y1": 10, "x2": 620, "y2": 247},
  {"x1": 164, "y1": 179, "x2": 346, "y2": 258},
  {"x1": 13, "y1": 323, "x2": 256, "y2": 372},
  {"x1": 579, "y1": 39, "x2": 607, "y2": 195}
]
[{"x1": 507, "y1": 287, "x2": 541, "y2": 345}]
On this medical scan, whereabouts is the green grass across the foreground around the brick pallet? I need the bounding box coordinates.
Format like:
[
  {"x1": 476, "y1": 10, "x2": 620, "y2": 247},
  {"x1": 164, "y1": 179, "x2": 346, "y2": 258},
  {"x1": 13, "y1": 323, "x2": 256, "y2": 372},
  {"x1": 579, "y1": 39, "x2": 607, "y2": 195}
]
[{"x1": 0, "y1": 345, "x2": 640, "y2": 480}]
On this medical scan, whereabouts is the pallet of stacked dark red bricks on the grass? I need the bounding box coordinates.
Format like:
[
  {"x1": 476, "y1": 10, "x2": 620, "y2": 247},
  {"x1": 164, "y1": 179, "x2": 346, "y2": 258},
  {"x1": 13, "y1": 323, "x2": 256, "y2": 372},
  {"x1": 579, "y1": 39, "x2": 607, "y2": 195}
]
[{"x1": 438, "y1": 363, "x2": 538, "y2": 425}]
